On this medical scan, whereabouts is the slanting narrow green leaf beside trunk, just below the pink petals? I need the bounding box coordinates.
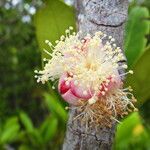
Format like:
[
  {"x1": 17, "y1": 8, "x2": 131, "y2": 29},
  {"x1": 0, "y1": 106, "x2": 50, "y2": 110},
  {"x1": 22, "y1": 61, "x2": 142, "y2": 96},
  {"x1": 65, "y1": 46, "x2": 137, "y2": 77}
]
[{"x1": 44, "y1": 93, "x2": 67, "y2": 123}]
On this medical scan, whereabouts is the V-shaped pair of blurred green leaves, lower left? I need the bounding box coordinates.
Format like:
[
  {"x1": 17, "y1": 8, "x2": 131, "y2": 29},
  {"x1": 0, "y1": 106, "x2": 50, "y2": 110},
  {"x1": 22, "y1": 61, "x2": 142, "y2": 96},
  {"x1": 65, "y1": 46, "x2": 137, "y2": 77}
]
[{"x1": 19, "y1": 112, "x2": 58, "y2": 150}]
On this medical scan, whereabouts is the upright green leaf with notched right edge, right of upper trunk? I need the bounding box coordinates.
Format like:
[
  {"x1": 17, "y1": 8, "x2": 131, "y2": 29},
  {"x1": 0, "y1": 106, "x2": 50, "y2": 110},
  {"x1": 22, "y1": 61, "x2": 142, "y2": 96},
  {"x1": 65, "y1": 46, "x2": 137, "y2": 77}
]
[{"x1": 125, "y1": 7, "x2": 150, "y2": 67}]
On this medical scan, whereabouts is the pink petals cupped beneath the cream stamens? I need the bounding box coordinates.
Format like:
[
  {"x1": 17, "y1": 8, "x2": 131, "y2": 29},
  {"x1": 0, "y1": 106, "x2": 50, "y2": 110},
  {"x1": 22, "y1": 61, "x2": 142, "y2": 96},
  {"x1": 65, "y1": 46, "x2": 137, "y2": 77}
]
[{"x1": 58, "y1": 73, "x2": 122, "y2": 105}]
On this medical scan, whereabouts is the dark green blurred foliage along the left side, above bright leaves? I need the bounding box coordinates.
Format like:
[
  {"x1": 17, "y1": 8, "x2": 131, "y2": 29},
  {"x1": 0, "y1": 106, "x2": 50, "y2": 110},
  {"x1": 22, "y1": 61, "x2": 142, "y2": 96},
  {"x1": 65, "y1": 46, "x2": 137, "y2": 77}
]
[{"x1": 0, "y1": 2, "x2": 43, "y2": 121}]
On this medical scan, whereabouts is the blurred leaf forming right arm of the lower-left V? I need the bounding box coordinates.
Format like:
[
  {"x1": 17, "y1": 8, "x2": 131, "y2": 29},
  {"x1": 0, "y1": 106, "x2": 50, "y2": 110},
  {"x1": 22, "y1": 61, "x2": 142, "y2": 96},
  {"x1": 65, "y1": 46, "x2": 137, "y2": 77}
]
[{"x1": 40, "y1": 116, "x2": 58, "y2": 143}]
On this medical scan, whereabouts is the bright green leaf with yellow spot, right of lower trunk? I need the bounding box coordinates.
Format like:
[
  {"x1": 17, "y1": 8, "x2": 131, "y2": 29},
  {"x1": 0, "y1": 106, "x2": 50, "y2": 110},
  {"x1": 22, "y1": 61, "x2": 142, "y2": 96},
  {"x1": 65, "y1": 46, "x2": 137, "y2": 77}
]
[{"x1": 114, "y1": 113, "x2": 150, "y2": 150}]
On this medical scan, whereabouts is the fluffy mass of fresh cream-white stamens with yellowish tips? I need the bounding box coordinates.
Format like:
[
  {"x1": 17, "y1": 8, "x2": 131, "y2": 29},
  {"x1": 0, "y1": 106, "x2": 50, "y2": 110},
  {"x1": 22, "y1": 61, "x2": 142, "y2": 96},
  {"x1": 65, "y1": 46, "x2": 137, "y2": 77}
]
[{"x1": 34, "y1": 27, "x2": 131, "y2": 98}]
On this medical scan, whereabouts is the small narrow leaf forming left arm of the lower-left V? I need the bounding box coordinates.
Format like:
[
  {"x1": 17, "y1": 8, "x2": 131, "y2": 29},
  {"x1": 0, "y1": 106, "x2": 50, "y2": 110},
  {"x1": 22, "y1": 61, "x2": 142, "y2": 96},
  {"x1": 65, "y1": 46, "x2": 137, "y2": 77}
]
[{"x1": 20, "y1": 112, "x2": 34, "y2": 132}]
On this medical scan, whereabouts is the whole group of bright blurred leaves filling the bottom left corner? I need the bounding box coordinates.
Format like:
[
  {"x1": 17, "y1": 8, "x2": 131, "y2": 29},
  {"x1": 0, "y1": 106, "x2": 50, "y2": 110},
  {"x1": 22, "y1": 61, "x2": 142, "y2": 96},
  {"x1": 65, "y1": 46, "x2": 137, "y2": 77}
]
[{"x1": 0, "y1": 112, "x2": 61, "y2": 150}]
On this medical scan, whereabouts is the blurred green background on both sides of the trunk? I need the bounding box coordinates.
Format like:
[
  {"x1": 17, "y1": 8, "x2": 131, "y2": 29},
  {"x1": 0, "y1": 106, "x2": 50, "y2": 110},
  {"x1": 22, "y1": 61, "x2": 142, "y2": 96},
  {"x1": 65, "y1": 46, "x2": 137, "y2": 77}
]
[{"x1": 0, "y1": 0, "x2": 150, "y2": 150}]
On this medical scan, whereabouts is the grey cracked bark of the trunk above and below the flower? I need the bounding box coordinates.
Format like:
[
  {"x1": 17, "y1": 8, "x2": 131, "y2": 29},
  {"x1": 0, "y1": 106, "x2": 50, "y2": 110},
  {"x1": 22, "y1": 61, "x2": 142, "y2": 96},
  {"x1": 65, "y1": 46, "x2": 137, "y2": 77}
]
[{"x1": 63, "y1": 0, "x2": 128, "y2": 150}]
